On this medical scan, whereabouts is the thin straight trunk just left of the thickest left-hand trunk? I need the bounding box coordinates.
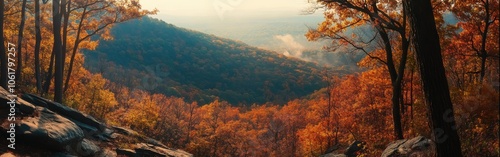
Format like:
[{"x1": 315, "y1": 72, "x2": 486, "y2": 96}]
[{"x1": 35, "y1": 0, "x2": 42, "y2": 94}]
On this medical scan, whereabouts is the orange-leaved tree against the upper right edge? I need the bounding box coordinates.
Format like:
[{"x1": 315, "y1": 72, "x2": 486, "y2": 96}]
[{"x1": 450, "y1": 0, "x2": 500, "y2": 81}]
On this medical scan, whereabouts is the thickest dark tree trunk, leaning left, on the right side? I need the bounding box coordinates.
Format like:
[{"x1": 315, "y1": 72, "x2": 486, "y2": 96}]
[{"x1": 404, "y1": 0, "x2": 462, "y2": 157}]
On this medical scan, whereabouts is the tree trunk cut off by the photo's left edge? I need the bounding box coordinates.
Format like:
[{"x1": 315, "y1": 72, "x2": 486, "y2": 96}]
[{"x1": 0, "y1": 1, "x2": 8, "y2": 89}]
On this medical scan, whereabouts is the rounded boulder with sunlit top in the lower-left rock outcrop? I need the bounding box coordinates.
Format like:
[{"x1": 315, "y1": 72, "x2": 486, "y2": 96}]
[{"x1": 16, "y1": 107, "x2": 84, "y2": 150}]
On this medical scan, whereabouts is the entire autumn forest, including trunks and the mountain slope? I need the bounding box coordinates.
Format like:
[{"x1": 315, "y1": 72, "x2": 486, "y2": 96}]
[{"x1": 0, "y1": 0, "x2": 500, "y2": 157}]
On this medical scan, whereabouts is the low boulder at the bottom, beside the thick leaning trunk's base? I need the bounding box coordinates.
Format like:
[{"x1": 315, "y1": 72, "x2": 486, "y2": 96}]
[{"x1": 382, "y1": 136, "x2": 434, "y2": 157}]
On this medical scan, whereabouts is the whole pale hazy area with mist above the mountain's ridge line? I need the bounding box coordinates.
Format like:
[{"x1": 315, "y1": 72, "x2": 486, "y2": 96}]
[{"x1": 140, "y1": 0, "x2": 330, "y2": 64}]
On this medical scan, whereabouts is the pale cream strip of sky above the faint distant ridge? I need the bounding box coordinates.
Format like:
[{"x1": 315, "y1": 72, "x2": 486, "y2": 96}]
[{"x1": 140, "y1": 0, "x2": 318, "y2": 21}]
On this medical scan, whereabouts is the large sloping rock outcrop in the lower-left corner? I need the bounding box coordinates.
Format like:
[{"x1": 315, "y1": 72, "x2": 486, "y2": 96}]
[{"x1": 0, "y1": 88, "x2": 193, "y2": 157}]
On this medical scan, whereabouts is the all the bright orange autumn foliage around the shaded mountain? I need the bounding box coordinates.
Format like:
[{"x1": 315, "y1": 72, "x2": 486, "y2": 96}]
[{"x1": 5, "y1": 0, "x2": 500, "y2": 156}]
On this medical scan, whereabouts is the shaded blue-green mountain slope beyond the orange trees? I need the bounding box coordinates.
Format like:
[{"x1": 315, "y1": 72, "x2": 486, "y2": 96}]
[{"x1": 85, "y1": 17, "x2": 323, "y2": 105}]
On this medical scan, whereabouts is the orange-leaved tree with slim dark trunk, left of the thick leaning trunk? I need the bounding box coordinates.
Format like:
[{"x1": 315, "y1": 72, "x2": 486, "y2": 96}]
[{"x1": 307, "y1": 0, "x2": 409, "y2": 139}]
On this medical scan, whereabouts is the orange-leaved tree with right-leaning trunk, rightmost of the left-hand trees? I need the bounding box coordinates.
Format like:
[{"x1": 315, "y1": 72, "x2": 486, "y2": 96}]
[{"x1": 64, "y1": 0, "x2": 157, "y2": 92}]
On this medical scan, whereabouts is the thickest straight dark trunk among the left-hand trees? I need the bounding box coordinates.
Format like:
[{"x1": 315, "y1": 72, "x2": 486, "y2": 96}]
[{"x1": 52, "y1": 0, "x2": 65, "y2": 103}]
